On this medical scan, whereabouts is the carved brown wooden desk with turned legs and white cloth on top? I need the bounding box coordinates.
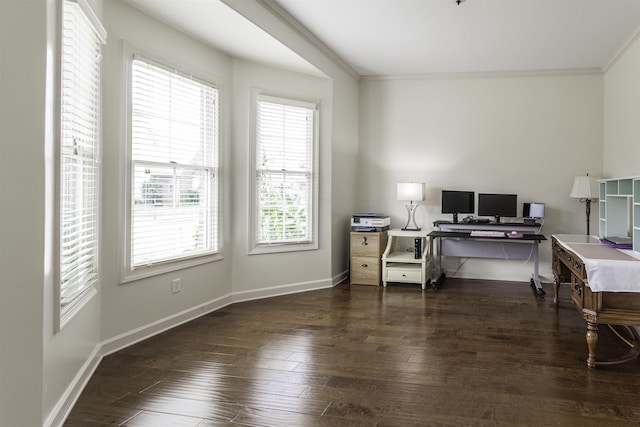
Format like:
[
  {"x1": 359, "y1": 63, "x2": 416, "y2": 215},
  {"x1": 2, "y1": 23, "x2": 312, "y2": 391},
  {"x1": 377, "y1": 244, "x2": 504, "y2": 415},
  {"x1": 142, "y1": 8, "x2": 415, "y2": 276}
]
[{"x1": 551, "y1": 234, "x2": 640, "y2": 368}]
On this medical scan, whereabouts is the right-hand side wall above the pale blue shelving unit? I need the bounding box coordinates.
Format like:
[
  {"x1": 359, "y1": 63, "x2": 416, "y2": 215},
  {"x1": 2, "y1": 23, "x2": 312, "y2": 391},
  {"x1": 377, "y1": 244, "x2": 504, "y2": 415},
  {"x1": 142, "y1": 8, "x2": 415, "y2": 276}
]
[{"x1": 603, "y1": 34, "x2": 640, "y2": 178}]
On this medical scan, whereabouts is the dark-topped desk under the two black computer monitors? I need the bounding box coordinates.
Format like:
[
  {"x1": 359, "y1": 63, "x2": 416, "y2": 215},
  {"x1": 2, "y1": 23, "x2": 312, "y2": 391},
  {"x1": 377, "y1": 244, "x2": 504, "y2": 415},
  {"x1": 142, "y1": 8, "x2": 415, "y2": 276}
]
[{"x1": 429, "y1": 221, "x2": 547, "y2": 296}]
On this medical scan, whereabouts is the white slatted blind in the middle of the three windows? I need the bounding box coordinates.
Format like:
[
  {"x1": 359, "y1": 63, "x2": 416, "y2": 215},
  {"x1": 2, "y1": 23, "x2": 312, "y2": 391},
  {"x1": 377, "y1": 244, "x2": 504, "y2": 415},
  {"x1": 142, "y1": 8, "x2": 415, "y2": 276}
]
[{"x1": 129, "y1": 56, "x2": 219, "y2": 269}]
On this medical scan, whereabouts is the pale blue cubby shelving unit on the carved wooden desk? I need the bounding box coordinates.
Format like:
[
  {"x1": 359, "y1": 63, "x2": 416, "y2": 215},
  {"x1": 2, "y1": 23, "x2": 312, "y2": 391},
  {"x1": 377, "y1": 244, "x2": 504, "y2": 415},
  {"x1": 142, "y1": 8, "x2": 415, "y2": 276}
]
[{"x1": 598, "y1": 176, "x2": 640, "y2": 252}]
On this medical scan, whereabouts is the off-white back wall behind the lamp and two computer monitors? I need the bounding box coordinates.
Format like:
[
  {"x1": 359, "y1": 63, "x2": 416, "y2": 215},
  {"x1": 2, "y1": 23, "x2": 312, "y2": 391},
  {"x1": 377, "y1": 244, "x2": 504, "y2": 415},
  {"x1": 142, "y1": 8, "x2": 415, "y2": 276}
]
[{"x1": 358, "y1": 75, "x2": 603, "y2": 281}]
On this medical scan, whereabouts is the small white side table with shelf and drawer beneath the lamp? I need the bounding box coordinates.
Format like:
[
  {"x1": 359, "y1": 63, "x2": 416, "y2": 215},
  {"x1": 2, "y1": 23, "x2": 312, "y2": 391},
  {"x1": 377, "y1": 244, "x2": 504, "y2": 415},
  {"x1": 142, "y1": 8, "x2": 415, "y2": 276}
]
[{"x1": 382, "y1": 229, "x2": 433, "y2": 289}]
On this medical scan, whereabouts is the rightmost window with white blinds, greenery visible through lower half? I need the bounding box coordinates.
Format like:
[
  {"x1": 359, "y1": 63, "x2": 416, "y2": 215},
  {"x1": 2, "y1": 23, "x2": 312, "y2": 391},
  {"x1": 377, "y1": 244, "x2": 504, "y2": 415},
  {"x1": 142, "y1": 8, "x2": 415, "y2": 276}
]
[{"x1": 252, "y1": 95, "x2": 317, "y2": 253}]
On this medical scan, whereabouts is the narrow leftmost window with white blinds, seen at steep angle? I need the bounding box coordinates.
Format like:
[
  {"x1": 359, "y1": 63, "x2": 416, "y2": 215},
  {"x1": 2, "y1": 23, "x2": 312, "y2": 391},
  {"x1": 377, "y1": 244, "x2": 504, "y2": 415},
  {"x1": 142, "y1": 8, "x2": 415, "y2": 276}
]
[{"x1": 56, "y1": 0, "x2": 106, "y2": 328}]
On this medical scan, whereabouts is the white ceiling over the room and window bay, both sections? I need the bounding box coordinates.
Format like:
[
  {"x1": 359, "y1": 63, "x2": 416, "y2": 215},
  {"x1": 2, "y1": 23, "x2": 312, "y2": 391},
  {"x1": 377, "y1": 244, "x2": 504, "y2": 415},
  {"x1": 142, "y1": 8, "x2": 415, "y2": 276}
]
[{"x1": 125, "y1": 0, "x2": 640, "y2": 76}]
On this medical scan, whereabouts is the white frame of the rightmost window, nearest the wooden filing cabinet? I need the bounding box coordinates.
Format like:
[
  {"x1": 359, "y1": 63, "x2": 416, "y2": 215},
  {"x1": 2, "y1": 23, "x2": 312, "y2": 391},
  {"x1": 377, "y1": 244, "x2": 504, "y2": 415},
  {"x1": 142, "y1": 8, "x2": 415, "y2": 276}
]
[{"x1": 248, "y1": 89, "x2": 320, "y2": 255}]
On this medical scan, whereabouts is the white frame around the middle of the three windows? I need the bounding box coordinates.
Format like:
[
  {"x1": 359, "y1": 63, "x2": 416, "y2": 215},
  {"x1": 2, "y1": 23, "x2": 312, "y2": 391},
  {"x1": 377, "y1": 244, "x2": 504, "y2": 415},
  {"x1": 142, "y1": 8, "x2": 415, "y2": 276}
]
[{"x1": 120, "y1": 49, "x2": 224, "y2": 284}]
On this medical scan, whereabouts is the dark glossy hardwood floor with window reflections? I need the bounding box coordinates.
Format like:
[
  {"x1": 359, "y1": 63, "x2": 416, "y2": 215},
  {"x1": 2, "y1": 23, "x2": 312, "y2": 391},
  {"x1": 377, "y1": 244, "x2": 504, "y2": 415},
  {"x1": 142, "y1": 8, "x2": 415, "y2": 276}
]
[{"x1": 65, "y1": 279, "x2": 640, "y2": 427}]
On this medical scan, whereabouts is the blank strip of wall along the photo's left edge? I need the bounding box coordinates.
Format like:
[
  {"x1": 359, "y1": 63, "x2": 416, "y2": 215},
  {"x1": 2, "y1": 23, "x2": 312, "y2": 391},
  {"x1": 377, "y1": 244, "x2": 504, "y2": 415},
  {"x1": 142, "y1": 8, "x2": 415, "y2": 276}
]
[{"x1": 0, "y1": 1, "x2": 52, "y2": 426}]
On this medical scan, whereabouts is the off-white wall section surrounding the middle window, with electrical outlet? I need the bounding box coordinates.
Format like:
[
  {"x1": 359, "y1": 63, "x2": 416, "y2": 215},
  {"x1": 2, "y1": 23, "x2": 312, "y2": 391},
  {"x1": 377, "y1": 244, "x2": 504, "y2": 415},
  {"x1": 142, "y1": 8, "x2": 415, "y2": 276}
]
[{"x1": 100, "y1": 1, "x2": 238, "y2": 347}]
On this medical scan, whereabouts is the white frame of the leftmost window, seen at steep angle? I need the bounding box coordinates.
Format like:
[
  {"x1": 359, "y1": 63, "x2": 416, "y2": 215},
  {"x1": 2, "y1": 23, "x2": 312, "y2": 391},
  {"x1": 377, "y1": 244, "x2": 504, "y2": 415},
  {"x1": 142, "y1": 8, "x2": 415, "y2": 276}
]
[{"x1": 54, "y1": 0, "x2": 107, "y2": 333}]
